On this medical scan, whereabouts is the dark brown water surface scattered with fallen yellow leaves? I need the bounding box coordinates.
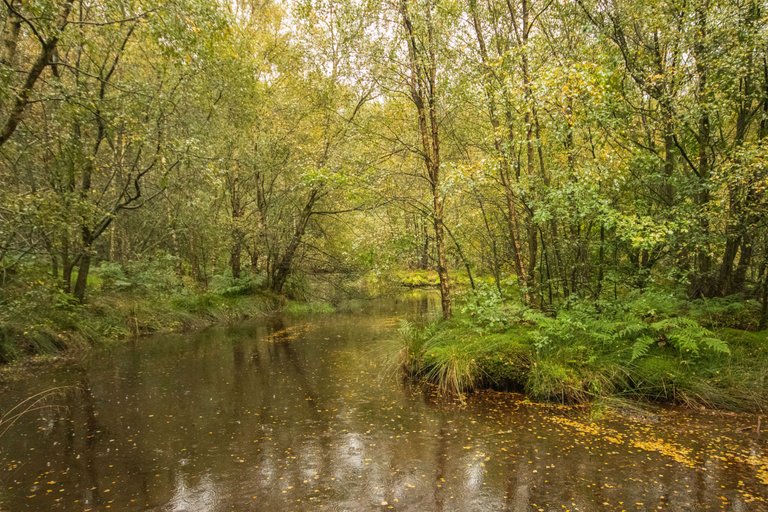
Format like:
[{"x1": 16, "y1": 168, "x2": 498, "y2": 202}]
[{"x1": 0, "y1": 298, "x2": 768, "y2": 512}]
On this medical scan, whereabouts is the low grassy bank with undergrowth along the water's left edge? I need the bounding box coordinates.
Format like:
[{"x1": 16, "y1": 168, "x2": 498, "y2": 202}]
[{"x1": 0, "y1": 261, "x2": 300, "y2": 363}]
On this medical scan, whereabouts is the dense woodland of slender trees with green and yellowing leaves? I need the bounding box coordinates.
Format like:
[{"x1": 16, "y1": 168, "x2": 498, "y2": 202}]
[{"x1": 0, "y1": 0, "x2": 768, "y2": 400}]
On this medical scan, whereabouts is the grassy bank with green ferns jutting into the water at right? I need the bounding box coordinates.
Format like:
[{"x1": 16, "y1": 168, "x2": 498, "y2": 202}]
[{"x1": 401, "y1": 289, "x2": 768, "y2": 411}]
